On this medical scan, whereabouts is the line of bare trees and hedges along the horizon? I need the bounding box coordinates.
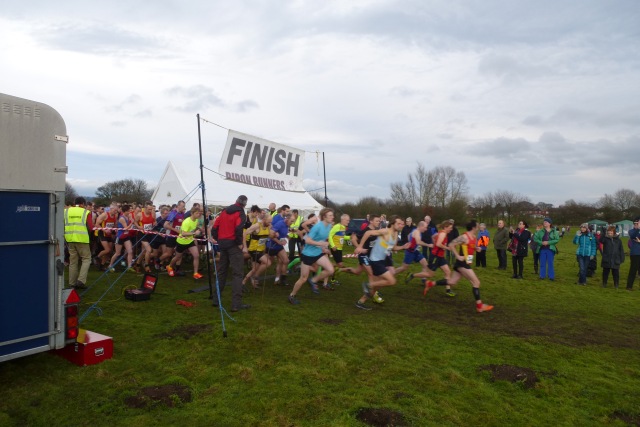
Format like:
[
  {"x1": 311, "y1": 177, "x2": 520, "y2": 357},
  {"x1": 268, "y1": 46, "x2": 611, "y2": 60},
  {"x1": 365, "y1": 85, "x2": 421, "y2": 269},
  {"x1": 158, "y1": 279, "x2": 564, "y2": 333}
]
[{"x1": 65, "y1": 163, "x2": 640, "y2": 226}]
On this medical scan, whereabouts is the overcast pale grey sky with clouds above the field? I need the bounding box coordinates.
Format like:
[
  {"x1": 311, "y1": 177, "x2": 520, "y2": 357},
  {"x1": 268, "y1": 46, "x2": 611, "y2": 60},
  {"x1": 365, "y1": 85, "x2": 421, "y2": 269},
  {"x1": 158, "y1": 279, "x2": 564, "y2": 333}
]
[{"x1": 0, "y1": 0, "x2": 640, "y2": 206}]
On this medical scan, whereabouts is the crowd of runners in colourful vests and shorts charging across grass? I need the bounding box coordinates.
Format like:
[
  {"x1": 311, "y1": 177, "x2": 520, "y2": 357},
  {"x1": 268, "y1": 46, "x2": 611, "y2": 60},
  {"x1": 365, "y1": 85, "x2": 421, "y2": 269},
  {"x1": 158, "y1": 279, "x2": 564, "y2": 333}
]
[{"x1": 74, "y1": 200, "x2": 493, "y2": 312}]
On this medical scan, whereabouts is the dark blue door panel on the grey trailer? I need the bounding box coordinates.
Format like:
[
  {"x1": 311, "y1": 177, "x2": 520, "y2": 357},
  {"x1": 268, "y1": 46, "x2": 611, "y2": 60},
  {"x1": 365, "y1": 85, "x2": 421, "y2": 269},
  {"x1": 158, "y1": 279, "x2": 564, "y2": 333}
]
[{"x1": 0, "y1": 190, "x2": 55, "y2": 361}]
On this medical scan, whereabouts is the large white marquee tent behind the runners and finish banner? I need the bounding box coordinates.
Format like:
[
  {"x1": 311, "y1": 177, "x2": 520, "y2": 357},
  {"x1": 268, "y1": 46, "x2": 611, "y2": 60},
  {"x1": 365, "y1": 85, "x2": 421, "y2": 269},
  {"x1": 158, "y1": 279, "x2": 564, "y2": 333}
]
[{"x1": 151, "y1": 161, "x2": 322, "y2": 214}]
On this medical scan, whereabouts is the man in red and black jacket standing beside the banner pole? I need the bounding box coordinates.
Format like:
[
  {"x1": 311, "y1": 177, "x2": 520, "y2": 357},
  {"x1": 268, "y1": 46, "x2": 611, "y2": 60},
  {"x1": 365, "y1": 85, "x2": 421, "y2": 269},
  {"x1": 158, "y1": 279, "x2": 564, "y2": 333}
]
[{"x1": 211, "y1": 196, "x2": 251, "y2": 311}]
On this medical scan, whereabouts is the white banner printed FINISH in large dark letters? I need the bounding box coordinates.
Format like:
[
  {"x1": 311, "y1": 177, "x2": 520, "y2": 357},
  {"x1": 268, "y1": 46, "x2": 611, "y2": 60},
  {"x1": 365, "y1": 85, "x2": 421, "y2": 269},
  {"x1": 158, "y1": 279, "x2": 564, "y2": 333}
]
[{"x1": 218, "y1": 129, "x2": 305, "y2": 192}]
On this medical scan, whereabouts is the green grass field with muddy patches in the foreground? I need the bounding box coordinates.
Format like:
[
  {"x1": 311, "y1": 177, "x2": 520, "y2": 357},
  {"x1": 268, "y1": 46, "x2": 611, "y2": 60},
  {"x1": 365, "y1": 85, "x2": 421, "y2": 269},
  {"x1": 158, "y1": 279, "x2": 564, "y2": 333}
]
[{"x1": 0, "y1": 232, "x2": 640, "y2": 426}]
